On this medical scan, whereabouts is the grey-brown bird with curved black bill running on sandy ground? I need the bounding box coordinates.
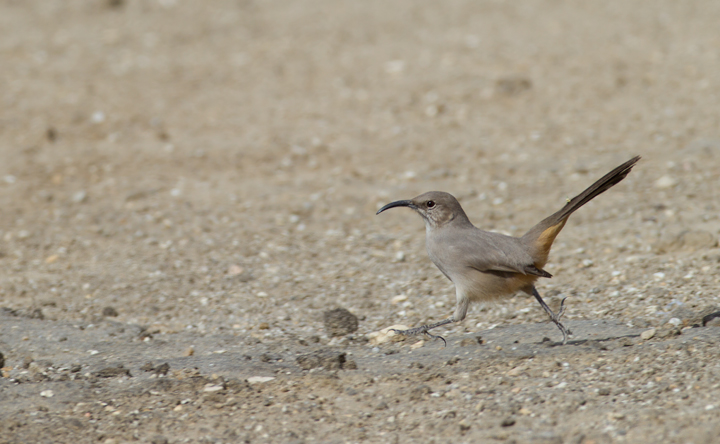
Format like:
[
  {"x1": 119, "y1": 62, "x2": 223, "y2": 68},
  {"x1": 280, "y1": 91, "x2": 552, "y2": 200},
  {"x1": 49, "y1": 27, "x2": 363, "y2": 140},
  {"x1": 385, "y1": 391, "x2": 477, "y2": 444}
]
[{"x1": 376, "y1": 156, "x2": 640, "y2": 345}]
